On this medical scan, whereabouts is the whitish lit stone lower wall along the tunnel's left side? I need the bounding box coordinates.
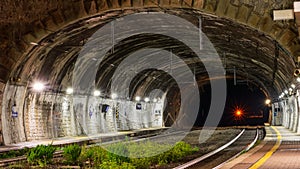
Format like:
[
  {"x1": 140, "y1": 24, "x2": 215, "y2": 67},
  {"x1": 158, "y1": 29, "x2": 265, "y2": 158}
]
[{"x1": 1, "y1": 85, "x2": 163, "y2": 144}]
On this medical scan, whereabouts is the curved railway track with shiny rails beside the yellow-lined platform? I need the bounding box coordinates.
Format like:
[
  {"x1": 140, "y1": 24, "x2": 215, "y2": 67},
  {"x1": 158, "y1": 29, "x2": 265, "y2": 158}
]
[{"x1": 173, "y1": 129, "x2": 262, "y2": 169}]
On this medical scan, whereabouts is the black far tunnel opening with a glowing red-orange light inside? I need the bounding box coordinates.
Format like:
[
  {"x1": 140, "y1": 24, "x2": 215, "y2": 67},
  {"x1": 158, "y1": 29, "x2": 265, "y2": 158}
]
[{"x1": 194, "y1": 79, "x2": 271, "y2": 127}]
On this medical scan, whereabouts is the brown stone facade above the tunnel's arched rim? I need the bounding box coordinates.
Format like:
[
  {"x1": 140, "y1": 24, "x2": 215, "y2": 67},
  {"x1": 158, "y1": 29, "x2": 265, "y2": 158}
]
[{"x1": 0, "y1": 0, "x2": 300, "y2": 82}]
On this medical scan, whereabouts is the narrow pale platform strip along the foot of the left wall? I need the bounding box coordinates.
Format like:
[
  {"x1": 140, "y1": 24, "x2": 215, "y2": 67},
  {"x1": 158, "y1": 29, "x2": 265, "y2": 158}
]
[{"x1": 0, "y1": 127, "x2": 169, "y2": 153}]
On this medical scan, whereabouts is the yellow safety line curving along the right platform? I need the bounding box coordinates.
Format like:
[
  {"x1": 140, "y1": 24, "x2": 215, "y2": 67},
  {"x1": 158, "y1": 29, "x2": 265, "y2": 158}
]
[{"x1": 249, "y1": 126, "x2": 281, "y2": 169}]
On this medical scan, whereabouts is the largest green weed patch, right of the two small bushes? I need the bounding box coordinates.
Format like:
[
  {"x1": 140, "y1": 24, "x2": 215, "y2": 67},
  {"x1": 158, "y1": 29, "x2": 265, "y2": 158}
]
[{"x1": 80, "y1": 141, "x2": 199, "y2": 169}]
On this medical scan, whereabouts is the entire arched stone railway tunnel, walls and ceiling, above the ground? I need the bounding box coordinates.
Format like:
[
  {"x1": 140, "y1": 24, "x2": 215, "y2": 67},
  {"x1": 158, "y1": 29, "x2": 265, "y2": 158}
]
[{"x1": 0, "y1": 0, "x2": 300, "y2": 145}]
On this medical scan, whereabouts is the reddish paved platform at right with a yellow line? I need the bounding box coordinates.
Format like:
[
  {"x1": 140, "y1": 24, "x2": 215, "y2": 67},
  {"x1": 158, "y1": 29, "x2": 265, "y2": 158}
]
[{"x1": 220, "y1": 126, "x2": 300, "y2": 169}]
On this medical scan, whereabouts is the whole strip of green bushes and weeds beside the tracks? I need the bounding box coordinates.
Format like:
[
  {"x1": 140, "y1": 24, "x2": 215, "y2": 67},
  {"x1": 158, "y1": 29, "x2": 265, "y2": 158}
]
[{"x1": 2, "y1": 141, "x2": 199, "y2": 169}]
